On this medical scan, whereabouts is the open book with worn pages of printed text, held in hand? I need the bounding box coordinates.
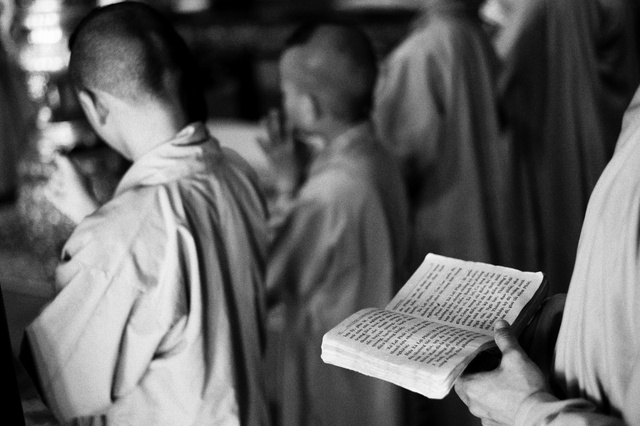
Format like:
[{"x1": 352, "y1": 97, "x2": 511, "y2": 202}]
[{"x1": 322, "y1": 254, "x2": 547, "y2": 399}]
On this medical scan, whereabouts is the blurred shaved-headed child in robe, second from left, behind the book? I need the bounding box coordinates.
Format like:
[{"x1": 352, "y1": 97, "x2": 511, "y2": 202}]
[{"x1": 267, "y1": 24, "x2": 408, "y2": 426}]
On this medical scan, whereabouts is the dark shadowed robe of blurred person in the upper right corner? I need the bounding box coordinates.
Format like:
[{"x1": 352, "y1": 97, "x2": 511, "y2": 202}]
[{"x1": 496, "y1": 0, "x2": 639, "y2": 293}]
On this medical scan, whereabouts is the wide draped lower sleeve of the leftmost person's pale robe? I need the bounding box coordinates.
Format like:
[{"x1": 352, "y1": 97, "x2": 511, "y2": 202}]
[{"x1": 26, "y1": 246, "x2": 171, "y2": 421}]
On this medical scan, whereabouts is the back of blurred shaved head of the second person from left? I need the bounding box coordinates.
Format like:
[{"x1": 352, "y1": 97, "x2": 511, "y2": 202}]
[{"x1": 280, "y1": 23, "x2": 378, "y2": 122}]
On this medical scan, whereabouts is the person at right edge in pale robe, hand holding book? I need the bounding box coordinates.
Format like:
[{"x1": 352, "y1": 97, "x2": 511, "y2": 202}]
[{"x1": 456, "y1": 84, "x2": 640, "y2": 425}]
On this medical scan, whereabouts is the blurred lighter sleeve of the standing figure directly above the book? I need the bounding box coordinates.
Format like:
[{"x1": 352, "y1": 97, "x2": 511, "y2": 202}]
[{"x1": 373, "y1": 35, "x2": 445, "y2": 183}]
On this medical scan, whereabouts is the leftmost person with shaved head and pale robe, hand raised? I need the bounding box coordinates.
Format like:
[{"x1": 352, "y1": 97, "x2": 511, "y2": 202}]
[{"x1": 23, "y1": 2, "x2": 270, "y2": 425}]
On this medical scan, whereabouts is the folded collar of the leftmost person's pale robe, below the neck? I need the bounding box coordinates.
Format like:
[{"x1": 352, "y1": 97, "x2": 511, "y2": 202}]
[{"x1": 115, "y1": 122, "x2": 222, "y2": 196}]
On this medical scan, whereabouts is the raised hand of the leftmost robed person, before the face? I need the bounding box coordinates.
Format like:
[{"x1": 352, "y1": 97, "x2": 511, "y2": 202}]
[{"x1": 44, "y1": 153, "x2": 99, "y2": 223}]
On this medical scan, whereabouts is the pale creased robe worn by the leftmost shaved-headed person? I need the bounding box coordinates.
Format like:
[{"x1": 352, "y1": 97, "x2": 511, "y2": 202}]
[{"x1": 27, "y1": 123, "x2": 269, "y2": 425}]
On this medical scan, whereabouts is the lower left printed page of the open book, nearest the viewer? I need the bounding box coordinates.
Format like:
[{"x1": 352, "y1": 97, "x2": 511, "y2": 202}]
[{"x1": 323, "y1": 309, "x2": 493, "y2": 377}]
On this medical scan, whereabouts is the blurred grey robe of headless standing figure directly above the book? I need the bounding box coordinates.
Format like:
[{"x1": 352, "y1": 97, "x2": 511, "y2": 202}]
[{"x1": 374, "y1": 0, "x2": 528, "y2": 268}]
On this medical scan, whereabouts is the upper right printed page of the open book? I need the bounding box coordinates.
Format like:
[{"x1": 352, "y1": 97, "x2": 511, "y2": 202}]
[{"x1": 387, "y1": 254, "x2": 543, "y2": 335}]
